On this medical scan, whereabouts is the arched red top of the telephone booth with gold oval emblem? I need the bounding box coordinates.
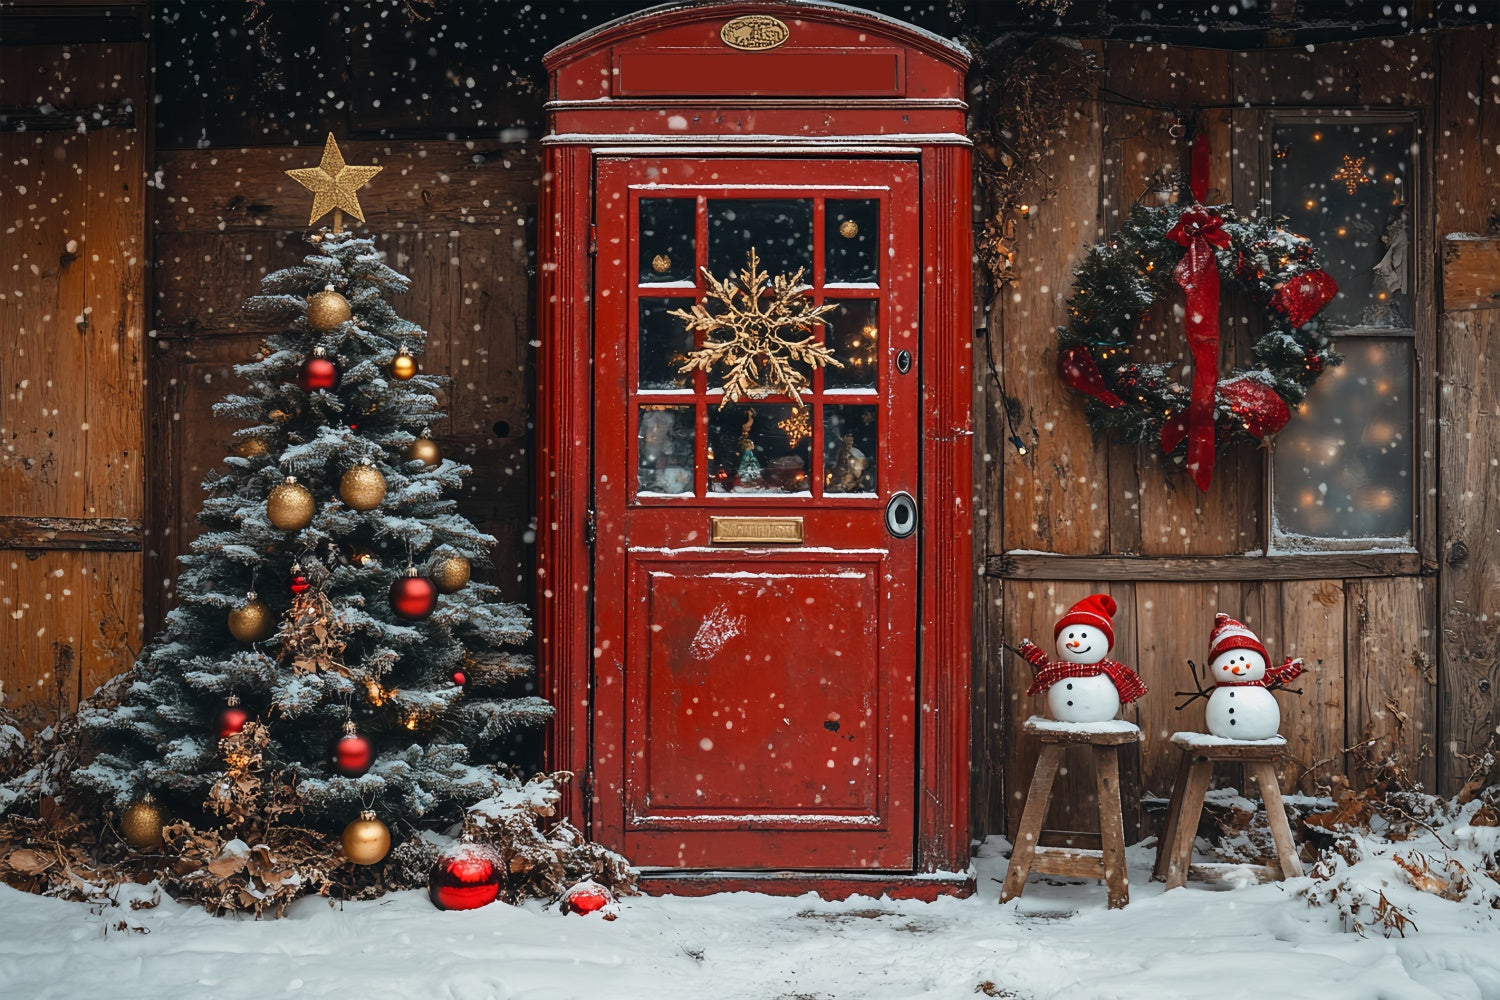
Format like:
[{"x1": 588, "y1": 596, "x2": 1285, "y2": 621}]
[{"x1": 545, "y1": 3, "x2": 969, "y2": 142}]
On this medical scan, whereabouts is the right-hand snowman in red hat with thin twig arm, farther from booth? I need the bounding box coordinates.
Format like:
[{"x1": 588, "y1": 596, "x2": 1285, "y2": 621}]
[{"x1": 1208, "y1": 612, "x2": 1302, "y2": 739}]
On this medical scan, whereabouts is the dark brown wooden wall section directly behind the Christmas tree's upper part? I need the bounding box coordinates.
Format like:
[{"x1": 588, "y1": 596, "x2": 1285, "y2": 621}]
[{"x1": 149, "y1": 141, "x2": 537, "y2": 621}]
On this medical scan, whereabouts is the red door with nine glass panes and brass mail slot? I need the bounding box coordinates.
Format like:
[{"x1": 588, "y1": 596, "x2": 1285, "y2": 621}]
[{"x1": 591, "y1": 157, "x2": 921, "y2": 870}]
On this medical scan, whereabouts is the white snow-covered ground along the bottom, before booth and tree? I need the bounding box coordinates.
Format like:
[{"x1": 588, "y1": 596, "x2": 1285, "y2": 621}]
[{"x1": 0, "y1": 828, "x2": 1500, "y2": 1000}]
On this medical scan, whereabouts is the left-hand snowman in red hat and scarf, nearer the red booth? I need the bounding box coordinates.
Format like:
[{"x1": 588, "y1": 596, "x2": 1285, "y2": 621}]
[{"x1": 1017, "y1": 594, "x2": 1146, "y2": 723}]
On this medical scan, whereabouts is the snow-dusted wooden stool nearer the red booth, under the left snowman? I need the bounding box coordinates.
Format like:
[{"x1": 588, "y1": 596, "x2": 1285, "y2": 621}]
[{"x1": 1001, "y1": 715, "x2": 1140, "y2": 910}]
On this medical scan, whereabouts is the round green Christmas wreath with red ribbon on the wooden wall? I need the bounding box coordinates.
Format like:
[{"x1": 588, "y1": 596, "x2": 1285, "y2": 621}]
[{"x1": 1058, "y1": 204, "x2": 1341, "y2": 490}]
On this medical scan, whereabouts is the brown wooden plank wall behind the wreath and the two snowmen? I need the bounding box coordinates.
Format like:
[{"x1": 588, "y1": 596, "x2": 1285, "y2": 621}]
[{"x1": 975, "y1": 28, "x2": 1500, "y2": 835}]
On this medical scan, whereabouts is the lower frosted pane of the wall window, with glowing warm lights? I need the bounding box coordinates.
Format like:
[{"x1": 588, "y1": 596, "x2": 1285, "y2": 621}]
[{"x1": 1274, "y1": 337, "x2": 1413, "y2": 547}]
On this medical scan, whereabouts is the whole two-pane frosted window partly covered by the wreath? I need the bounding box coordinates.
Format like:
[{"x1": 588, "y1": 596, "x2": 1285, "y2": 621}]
[{"x1": 1271, "y1": 117, "x2": 1416, "y2": 550}]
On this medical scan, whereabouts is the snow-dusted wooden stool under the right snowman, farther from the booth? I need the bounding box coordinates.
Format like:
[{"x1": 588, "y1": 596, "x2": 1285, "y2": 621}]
[{"x1": 1151, "y1": 733, "x2": 1302, "y2": 889}]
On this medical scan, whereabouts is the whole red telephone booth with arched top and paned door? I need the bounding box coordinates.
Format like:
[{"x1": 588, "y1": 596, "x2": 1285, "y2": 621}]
[{"x1": 537, "y1": 1, "x2": 974, "y2": 895}]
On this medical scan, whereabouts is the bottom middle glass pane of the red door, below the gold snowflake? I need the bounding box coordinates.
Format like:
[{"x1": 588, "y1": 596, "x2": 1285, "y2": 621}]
[{"x1": 707, "y1": 403, "x2": 813, "y2": 493}]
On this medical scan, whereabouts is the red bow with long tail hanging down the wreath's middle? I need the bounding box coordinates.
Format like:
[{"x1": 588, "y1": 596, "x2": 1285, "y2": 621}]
[{"x1": 1161, "y1": 204, "x2": 1229, "y2": 492}]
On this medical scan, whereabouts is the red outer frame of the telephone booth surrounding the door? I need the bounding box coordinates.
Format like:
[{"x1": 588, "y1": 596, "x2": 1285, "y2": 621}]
[{"x1": 537, "y1": 1, "x2": 974, "y2": 895}]
